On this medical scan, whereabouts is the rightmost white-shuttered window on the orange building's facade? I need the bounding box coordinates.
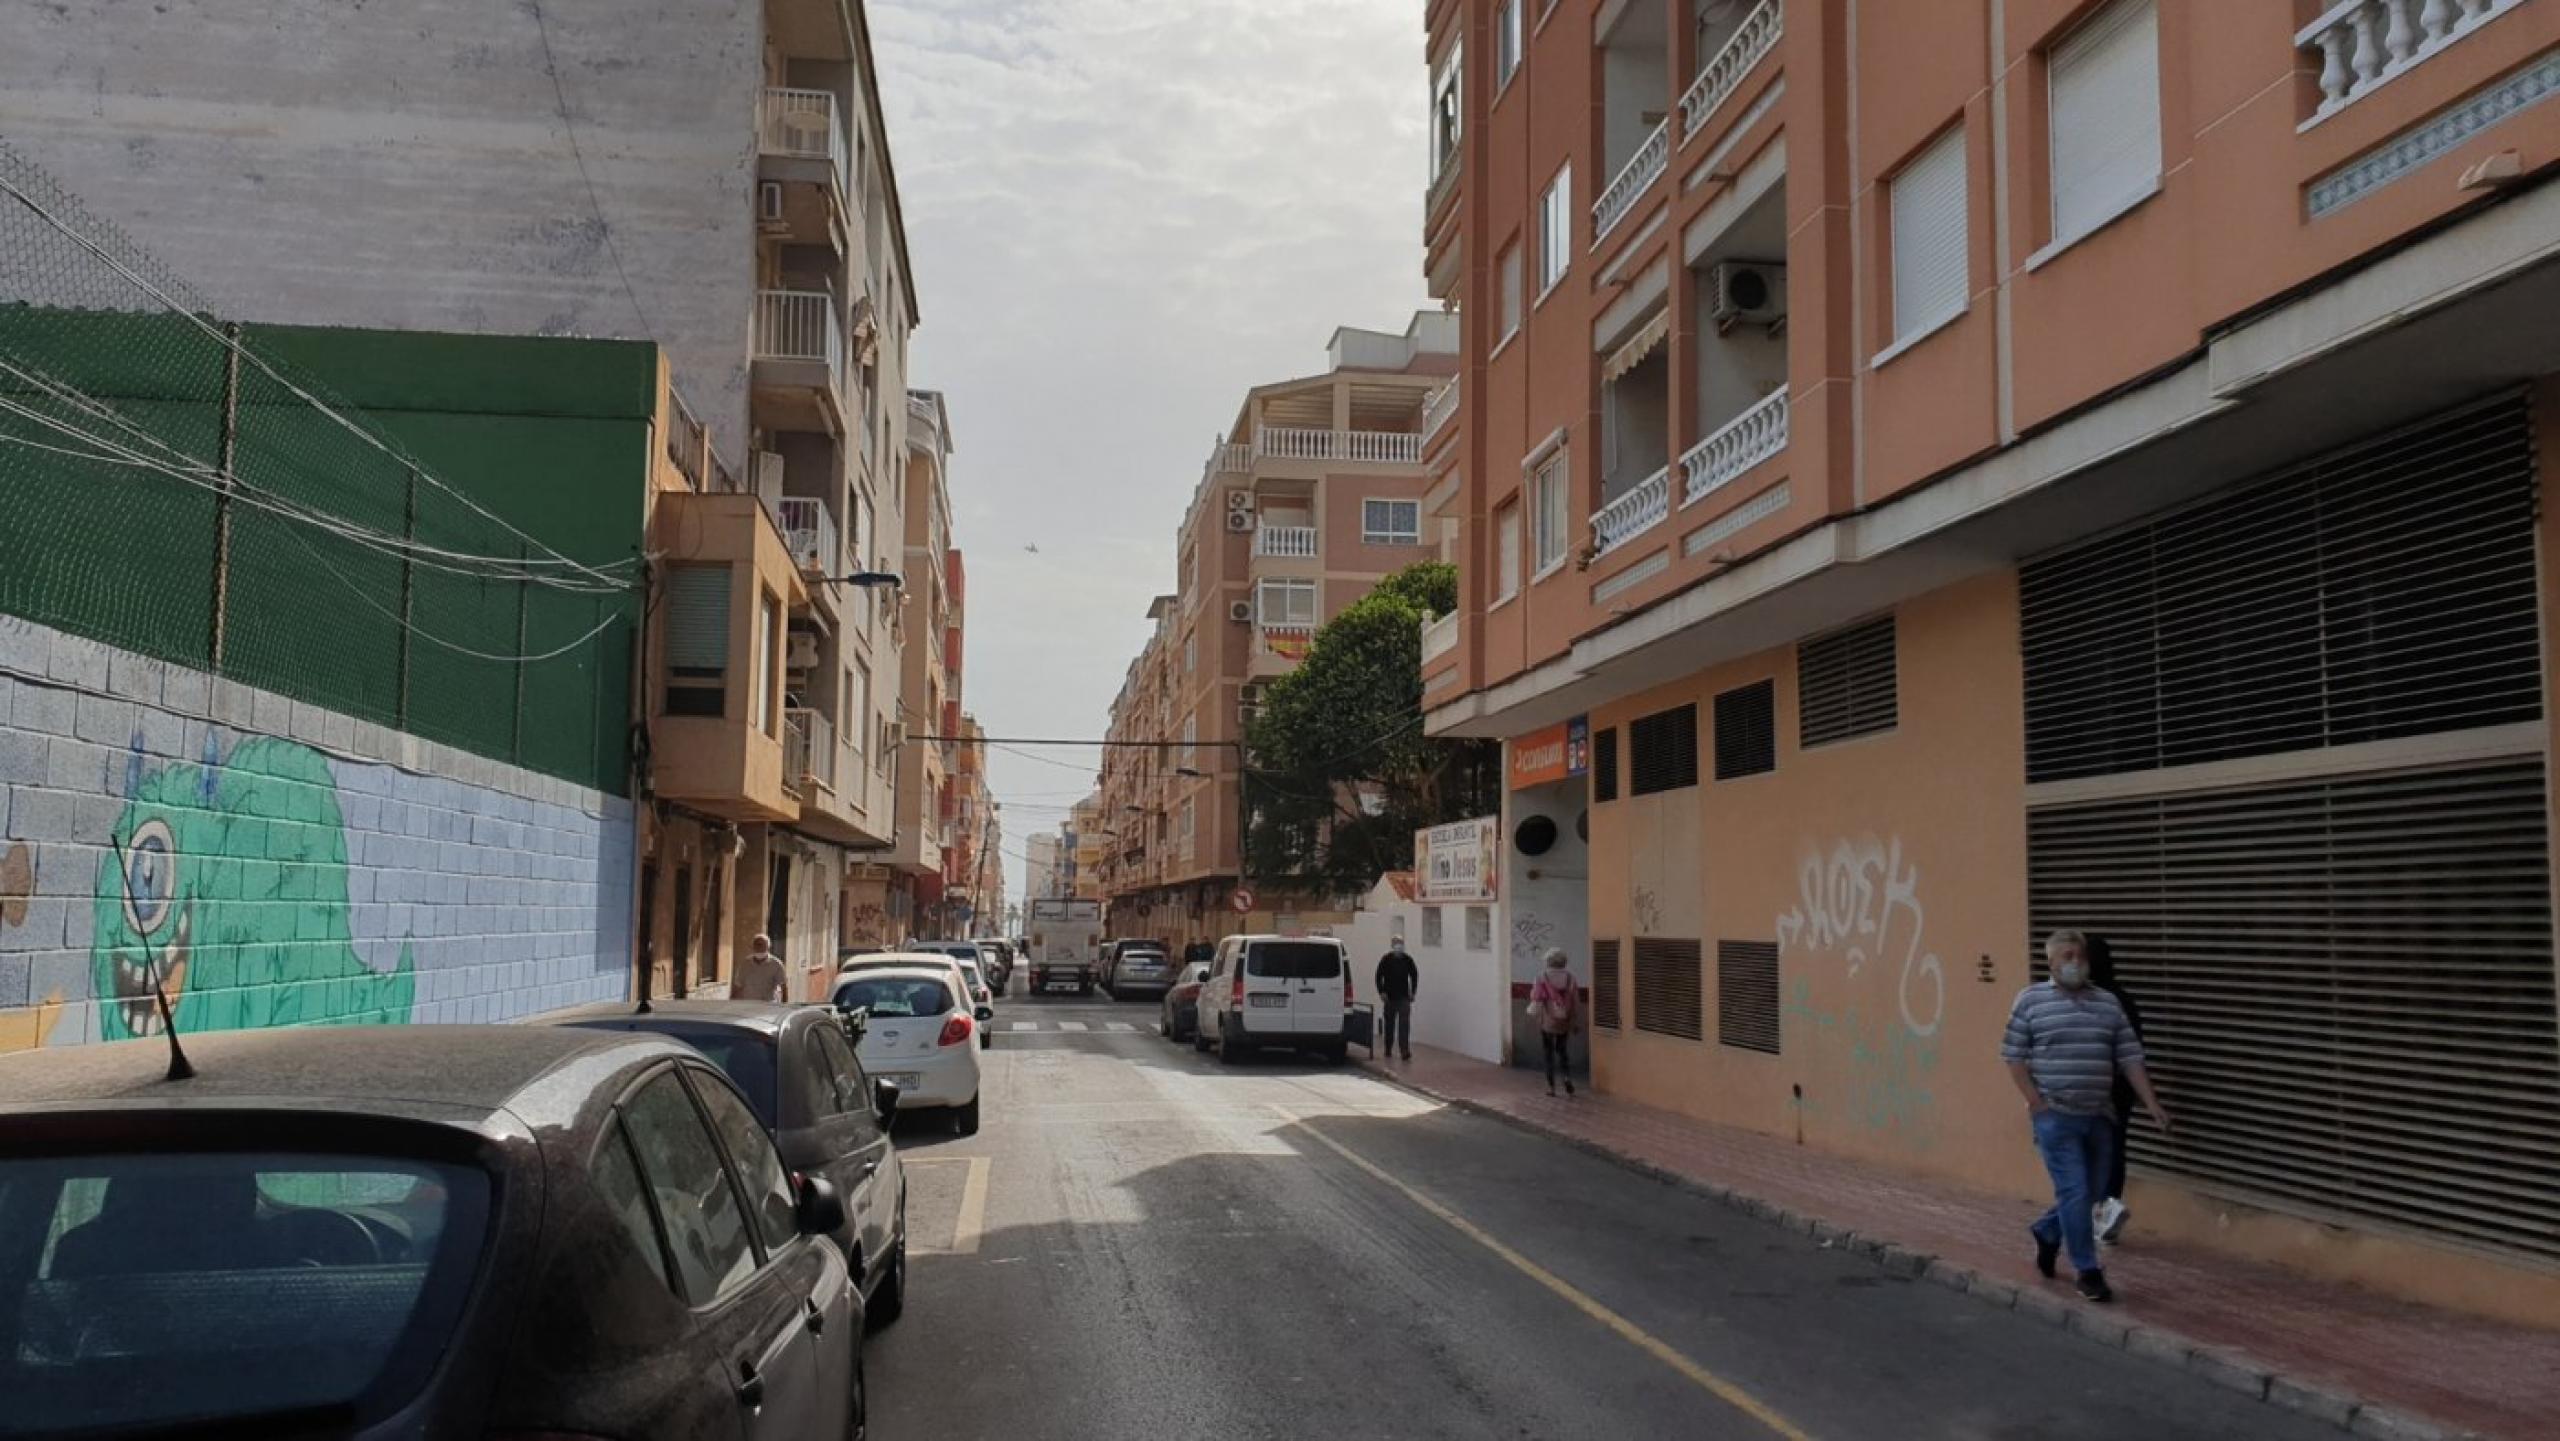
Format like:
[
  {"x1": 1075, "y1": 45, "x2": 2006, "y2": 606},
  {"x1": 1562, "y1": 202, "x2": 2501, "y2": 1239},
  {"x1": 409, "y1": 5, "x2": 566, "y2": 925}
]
[{"x1": 2045, "y1": 0, "x2": 2161, "y2": 243}]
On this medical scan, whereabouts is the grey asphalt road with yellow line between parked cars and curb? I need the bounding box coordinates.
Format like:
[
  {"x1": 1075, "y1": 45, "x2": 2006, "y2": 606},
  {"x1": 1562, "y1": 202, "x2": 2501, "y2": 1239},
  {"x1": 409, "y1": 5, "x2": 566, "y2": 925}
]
[{"x1": 870, "y1": 991, "x2": 2337, "y2": 1441}]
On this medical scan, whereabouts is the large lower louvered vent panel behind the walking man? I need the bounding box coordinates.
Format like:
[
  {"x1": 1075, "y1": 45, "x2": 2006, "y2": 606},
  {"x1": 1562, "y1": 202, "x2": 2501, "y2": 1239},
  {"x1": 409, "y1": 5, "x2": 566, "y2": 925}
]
[{"x1": 2028, "y1": 760, "x2": 2560, "y2": 1259}]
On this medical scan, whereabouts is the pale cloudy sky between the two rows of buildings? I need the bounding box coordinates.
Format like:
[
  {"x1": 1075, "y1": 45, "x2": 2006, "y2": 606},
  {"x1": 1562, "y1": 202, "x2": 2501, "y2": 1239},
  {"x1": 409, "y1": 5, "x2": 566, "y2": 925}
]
[{"x1": 870, "y1": 0, "x2": 1428, "y2": 921}]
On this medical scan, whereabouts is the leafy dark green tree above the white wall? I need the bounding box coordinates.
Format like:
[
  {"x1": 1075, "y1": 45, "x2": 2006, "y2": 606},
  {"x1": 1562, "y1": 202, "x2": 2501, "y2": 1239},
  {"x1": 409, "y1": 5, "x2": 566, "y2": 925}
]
[{"x1": 1244, "y1": 561, "x2": 1503, "y2": 891}]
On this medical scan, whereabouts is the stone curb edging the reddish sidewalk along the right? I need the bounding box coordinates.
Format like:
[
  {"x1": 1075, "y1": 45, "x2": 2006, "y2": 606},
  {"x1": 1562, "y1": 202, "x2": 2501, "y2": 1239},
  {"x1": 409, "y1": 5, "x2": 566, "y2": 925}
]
[{"x1": 1362, "y1": 1060, "x2": 2491, "y2": 1441}]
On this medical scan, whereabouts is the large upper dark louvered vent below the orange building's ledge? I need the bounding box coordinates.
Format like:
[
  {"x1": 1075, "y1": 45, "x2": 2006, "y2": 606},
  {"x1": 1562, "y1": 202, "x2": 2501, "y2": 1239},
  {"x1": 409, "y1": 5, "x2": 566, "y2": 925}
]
[{"x1": 2020, "y1": 399, "x2": 2542, "y2": 781}]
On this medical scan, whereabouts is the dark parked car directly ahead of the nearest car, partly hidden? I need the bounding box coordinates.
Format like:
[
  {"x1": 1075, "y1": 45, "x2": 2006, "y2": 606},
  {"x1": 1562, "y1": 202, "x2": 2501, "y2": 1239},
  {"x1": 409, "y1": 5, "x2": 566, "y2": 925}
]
[{"x1": 535, "y1": 1001, "x2": 906, "y2": 1328}]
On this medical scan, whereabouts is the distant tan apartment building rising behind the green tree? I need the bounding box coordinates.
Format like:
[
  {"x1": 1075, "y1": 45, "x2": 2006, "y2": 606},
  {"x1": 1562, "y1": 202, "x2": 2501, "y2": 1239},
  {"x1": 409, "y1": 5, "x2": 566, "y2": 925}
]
[{"x1": 1098, "y1": 312, "x2": 1459, "y2": 944}]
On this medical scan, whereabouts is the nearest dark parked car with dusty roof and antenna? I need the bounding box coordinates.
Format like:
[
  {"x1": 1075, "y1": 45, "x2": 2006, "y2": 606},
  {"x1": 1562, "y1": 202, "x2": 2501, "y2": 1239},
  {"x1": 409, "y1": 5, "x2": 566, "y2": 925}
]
[{"x1": 0, "y1": 1026, "x2": 863, "y2": 1438}]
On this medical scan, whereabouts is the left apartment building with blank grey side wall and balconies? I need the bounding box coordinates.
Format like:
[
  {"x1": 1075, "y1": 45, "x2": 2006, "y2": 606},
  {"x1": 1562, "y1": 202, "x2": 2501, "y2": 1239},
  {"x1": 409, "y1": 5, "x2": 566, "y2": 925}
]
[{"x1": 0, "y1": 0, "x2": 916, "y2": 993}]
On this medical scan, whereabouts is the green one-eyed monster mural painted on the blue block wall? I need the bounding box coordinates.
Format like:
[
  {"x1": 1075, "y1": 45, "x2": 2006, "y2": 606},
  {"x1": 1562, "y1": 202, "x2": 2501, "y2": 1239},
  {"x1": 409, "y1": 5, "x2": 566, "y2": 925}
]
[{"x1": 90, "y1": 737, "x2": 417, "y2": 1042}]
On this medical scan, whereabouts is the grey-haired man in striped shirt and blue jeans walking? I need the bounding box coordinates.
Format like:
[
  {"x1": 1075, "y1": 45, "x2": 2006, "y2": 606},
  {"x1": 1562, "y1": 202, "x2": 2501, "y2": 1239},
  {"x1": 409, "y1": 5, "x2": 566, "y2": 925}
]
[{"x1": 1999, "y1": 932, "x2": 2168, "y2": 1300}]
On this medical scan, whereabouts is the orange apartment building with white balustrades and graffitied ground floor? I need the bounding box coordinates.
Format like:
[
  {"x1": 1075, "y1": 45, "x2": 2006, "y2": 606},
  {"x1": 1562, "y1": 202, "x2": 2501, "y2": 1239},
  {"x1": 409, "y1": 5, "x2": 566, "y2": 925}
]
[{"x1": 1423, "y1": 0, "x2": 2560, "y2": 1323}]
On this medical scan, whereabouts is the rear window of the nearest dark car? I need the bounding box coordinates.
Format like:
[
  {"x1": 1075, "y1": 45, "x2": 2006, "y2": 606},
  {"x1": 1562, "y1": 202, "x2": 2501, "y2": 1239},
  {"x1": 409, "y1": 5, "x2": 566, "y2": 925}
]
[{"x1": 0, "y1": 1152, "x2": 489, "y2": 1436}]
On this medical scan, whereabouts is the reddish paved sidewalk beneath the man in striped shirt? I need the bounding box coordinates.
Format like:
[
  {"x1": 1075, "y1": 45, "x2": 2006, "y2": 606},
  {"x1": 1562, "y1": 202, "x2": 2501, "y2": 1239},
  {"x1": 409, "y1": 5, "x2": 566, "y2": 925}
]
[{"x1": 1370, "y1": 1047, "x2": 2560, "y2": 1441}]
